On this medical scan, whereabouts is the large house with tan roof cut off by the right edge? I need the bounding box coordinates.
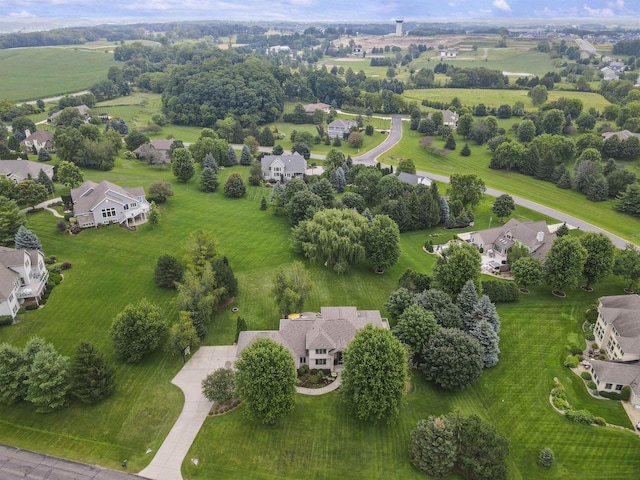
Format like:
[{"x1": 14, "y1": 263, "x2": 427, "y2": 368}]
[{"x1": 589, "y1": 294, "x2": 640, "y2": 405}]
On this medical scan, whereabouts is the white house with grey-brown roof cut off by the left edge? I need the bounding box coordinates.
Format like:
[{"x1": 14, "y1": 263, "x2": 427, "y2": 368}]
[{"x1": 0, "y1": 247, "x2": 49, "y2": 318}]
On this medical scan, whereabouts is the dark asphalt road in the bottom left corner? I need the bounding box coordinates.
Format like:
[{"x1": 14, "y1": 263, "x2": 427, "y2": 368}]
[{"x1": 0, "y1": 445, "x2": 144, "y2": 480}]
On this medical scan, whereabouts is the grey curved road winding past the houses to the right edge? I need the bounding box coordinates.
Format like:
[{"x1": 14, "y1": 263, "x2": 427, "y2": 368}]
[{"x1": 353, "y1": 115, "x2": 631, "y2": 248}]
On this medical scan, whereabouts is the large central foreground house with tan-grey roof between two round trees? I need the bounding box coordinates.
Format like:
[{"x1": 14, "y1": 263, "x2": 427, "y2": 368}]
[{"x1": 238, "y1": 307, "x2": 389, "y2": 371}]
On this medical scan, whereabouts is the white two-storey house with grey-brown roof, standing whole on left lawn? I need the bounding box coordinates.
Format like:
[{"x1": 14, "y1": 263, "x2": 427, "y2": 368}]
[{"x1": 71, "y1": 180, "x2": 149, "y2": 228}]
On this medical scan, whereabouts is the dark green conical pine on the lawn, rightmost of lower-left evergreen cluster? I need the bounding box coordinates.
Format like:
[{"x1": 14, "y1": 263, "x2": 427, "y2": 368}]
[{"x1": 70, "y1": 342, "x2": 116, "y2": 403}]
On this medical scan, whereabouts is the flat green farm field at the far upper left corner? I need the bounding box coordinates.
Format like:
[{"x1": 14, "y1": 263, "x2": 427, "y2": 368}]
[{"x1": 0, "y1": 47, "x2": 119, "y2": 101}]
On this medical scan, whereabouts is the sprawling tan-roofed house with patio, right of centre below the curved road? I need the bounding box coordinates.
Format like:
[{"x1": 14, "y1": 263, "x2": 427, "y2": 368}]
[{"x1": 458, "y1": 218, "x2": 555, "y2": 261}]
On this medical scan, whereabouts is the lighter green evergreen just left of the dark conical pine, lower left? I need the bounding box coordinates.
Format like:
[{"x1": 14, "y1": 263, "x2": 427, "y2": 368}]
[{"x1": 25, "y1": 344, "x2": 69, "y2": 413}]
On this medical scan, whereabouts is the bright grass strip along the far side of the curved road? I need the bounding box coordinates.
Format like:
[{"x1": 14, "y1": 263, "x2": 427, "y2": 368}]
[{"x1": 380, "y1": 124, "x2": 640, "y2": 243}]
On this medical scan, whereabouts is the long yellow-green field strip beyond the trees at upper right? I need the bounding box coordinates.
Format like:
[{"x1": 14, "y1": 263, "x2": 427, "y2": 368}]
[{"x1": 402, "y1": 88, "x2": 610, "y2": 111}]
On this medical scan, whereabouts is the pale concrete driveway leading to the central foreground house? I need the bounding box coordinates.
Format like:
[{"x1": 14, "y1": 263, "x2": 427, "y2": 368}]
[{"x1": 140, "y1": 345, "x2": 236, "y2": 480}]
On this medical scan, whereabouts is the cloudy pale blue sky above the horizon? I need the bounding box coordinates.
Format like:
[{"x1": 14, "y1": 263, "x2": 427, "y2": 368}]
[{"x1": 0, "y1": 0, "x2": 640, "y2": 22}]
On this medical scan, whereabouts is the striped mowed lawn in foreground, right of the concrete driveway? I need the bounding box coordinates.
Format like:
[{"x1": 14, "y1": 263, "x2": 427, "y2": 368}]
[{"x1": 182, "y1": 282, "x2": 640, "y2": 480}]
